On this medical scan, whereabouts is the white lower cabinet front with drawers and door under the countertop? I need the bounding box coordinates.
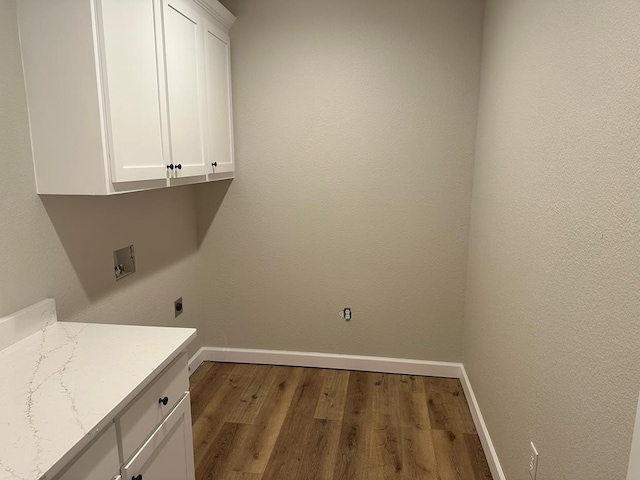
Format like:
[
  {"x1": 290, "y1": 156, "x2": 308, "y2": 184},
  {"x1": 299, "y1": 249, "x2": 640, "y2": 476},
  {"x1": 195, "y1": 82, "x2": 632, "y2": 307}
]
[{"x1": 55, "y1": 353, "x2": 195, "y2": 480}]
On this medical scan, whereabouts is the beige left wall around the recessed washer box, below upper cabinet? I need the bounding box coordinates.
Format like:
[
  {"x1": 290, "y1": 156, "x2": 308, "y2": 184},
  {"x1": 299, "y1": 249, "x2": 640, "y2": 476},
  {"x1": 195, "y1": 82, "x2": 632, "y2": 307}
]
[{"x1": 0, "y1": 0, "x2": 200, "y2": 356}]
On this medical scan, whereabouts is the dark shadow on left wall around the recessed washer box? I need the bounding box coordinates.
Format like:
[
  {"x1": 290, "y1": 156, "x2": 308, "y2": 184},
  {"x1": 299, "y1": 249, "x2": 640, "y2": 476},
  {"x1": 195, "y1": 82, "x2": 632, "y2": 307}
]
[{"x1": 40, "y1": 186, "x2": 198, "y2": 302}]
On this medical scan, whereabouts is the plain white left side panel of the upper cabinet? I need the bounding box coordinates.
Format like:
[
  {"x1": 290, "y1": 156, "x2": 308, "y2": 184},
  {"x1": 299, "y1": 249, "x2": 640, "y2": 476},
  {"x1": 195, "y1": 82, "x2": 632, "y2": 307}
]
[{"x1": 17, "y1": 0, "x2": 106, "y2": 194}]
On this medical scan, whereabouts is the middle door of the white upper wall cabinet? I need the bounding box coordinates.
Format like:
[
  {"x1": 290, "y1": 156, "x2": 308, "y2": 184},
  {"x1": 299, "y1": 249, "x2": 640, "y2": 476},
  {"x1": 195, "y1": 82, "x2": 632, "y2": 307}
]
[{"x1": 164, "y1": 0, "x2": 211, "y2": 177}]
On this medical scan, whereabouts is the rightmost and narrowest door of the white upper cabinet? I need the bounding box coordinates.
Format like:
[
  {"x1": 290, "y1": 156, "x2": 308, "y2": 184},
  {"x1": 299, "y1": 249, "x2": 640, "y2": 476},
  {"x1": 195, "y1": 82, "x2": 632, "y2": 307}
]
[{"x1": 204, "y1": 21, "x2": 234, "y2": 173}]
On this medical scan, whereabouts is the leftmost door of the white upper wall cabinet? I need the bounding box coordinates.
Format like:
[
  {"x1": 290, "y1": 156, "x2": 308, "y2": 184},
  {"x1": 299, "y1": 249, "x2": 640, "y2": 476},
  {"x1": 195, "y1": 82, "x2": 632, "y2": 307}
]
[{"x1": 98, "y1": 0, "x2": 168, "y2": 182}]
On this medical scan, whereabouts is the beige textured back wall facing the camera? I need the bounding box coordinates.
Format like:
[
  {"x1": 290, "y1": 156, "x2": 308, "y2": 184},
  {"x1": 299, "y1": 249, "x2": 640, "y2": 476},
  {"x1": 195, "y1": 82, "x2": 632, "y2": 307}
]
[{"x1": 197, "y1": 0, "x2": 483, "y2": 360}]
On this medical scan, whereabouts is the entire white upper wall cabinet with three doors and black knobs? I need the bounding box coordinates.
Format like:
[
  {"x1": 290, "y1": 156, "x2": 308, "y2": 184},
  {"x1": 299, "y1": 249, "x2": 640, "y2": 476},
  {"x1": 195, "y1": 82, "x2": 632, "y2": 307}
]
[{"x1": 17, "y1": 0, "x2": 235, "y2": 195}]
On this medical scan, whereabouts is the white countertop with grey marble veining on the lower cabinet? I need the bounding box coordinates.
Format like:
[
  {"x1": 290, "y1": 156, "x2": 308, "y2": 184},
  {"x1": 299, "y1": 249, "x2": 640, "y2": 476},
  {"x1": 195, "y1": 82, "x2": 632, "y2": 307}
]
[{"x1": 0, "y1": 300, "x2": 196, "y2": 480}]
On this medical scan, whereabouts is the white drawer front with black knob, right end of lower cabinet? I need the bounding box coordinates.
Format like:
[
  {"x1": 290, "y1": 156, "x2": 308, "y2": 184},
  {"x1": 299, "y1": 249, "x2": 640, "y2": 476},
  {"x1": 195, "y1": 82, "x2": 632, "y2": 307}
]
[{"x1": 117, "y1": 353, "x2": 189, "y2": 459}]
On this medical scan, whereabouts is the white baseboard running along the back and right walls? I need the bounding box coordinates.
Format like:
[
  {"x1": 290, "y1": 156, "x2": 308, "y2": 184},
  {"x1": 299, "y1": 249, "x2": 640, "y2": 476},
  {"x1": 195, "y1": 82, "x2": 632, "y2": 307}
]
[{"x1": 189, "y1": 347, "x2": 506, "y2": 480}]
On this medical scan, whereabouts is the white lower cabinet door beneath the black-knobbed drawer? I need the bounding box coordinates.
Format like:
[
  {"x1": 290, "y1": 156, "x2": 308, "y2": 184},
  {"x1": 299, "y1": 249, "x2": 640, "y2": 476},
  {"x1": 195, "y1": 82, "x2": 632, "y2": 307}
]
[{"x1": 121, "y1": 392, "x2": 195, "y2": 480}]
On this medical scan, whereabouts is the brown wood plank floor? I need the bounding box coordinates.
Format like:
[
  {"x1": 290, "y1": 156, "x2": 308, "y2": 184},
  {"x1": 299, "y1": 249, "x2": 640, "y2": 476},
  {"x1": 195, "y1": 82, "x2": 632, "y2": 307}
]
[{"x1": 191, "y1": 362, "x2": 491, "y2": 480}]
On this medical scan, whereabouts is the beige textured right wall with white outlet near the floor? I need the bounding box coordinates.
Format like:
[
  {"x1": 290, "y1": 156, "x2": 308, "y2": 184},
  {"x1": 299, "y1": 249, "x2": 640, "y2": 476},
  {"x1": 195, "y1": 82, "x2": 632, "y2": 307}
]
[{"x1": 464, "y1": 0, "x2": 640, "y2": 480}]
